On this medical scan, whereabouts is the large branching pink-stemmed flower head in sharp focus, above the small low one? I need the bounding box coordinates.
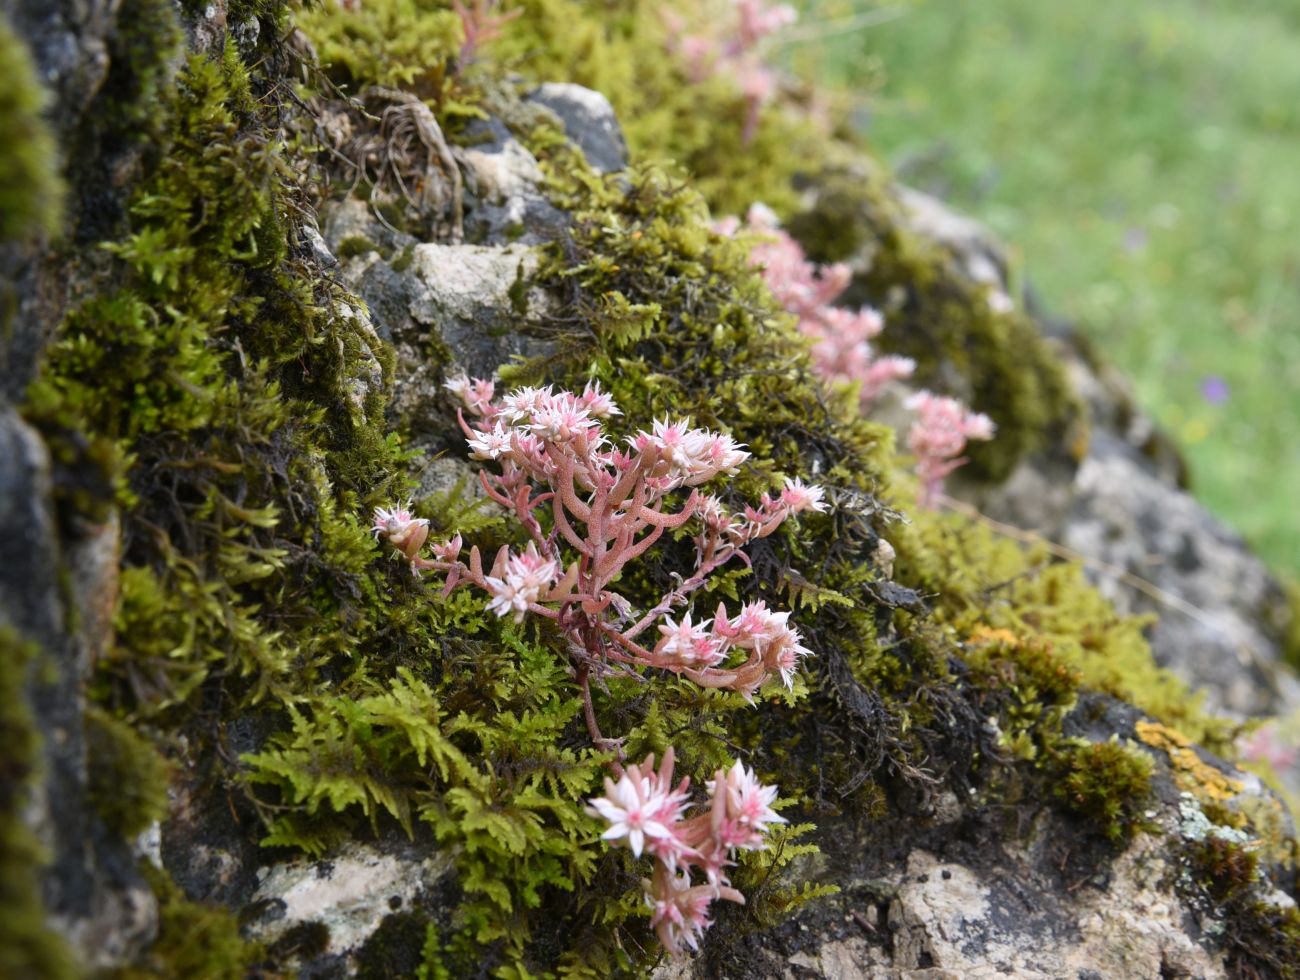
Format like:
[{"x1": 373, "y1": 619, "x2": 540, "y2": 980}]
[{"x1": 373, "y1": 377, "x2": 826, "y2": 747}]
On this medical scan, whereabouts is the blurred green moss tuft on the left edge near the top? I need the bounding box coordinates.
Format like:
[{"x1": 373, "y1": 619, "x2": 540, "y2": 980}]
[{"x1": 0, "y1": 14, "x2": 62, "y2": 242}]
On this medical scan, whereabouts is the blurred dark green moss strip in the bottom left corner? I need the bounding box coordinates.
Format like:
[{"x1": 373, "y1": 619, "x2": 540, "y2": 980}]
[{"x1": 0, "y1": 624, "x2": 78, "y2": 980}]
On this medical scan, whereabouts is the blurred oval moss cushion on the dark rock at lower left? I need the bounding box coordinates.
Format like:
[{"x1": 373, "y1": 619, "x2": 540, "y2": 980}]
[{"x1": 86, "y1": 707, "x2": 172, "y2": 837}]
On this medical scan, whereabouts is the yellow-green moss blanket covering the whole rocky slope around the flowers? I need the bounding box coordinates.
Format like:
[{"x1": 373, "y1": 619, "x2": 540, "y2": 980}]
[{"x1": 0, "y1": 0, "x2": 1300, "y2": 977}]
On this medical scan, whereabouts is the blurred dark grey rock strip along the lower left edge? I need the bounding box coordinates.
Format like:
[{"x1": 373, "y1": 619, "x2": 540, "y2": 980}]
[{"x1": 0, "y1": 407, "x2": 157, "y2": 967}]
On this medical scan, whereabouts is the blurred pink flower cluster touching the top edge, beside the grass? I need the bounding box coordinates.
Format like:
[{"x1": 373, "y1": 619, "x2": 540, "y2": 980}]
[{"x1": 662, "y1": 0, "x2": 797, "y2": 143}]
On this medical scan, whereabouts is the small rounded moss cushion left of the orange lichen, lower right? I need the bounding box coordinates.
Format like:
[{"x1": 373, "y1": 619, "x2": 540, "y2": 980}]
[{"x1": 1053, "y1": 737, "x2": 1156, "y2": 844}]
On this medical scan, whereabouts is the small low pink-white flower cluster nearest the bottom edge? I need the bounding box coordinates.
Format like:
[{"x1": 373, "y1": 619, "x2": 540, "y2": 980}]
[{"x1": 588, "y1": 749, "x2": 785, "y2": 955}]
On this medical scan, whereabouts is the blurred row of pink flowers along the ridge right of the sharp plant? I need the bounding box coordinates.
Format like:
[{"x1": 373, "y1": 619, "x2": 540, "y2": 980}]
[{"x1": 733, "y1": 204, "x2": 995, "y2": 507}]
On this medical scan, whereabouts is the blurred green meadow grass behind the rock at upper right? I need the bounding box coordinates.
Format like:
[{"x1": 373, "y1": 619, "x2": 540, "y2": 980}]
[{"x1": 785, "y1": 0, "x2": 1300, "y2": 574}]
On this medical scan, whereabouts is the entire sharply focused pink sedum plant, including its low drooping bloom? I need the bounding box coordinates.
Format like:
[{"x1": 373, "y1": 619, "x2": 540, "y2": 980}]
[{"x1": 373, "y1": 376, "x2": 826, "y2": 954}]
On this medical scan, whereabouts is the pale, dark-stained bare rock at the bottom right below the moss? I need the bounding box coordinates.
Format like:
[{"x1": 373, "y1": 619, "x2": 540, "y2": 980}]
[{"x1": 655, "y1": 686, "x2": 1294, "y2": 980}]
